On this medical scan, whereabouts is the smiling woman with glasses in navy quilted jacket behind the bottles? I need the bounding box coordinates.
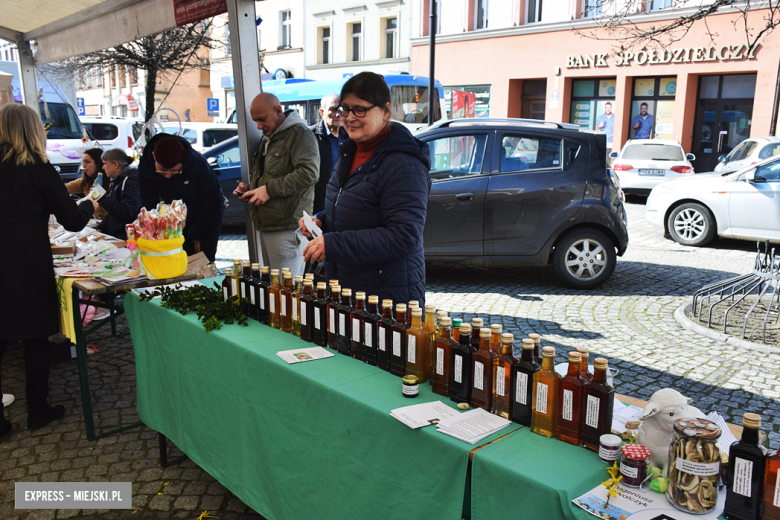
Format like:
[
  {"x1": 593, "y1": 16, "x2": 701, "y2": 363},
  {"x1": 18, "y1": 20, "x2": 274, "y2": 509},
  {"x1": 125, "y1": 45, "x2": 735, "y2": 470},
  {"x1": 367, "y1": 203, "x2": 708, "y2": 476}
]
[{"x1": 300, "y1": 72, "x2": 431, "y2": 308}]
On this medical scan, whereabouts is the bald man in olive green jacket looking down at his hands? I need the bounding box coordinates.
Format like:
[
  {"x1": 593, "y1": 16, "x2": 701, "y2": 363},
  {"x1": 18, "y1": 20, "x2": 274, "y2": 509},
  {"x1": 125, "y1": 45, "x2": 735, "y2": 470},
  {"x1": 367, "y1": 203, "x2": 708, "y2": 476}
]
[{"x1": 237, "y1": 93, "x2": 320, "y2": 274}]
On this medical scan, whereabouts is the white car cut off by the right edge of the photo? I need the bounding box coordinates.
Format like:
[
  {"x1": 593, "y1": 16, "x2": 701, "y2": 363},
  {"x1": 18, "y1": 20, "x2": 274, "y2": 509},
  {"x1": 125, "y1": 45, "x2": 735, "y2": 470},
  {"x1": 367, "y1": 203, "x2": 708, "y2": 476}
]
[{"x1": 645, "y1": 156, "x2": 780, "y2": 246}]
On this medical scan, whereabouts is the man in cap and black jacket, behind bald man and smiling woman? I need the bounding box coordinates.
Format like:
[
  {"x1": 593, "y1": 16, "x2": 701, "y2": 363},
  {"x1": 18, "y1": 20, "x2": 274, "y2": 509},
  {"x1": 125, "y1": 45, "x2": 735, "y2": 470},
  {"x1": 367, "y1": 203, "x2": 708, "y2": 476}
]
[{"x1": 309, "y1": 94, "x2": 349, "y2": 214}]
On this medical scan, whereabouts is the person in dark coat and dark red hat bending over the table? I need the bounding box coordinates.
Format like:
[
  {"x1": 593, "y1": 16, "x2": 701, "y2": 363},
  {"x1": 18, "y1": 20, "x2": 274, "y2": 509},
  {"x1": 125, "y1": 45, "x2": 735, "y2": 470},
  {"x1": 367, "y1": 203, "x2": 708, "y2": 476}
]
[{"x1": 138, "y1": 134, "x2": 225, "y2": 262}]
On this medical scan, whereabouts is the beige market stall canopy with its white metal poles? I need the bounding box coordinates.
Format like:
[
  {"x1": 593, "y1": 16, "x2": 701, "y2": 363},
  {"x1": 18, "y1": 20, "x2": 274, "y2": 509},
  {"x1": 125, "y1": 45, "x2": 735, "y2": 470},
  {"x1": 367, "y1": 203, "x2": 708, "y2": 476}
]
[{"x1": 0, "y1": 0, "x2": 262, "y2": 262}]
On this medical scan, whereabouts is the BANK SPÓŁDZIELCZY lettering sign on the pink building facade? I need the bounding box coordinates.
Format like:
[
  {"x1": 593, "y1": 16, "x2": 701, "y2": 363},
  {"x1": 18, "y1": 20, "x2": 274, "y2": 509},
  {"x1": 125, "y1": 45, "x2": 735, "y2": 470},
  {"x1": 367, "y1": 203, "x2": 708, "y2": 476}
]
[{"x1": 566, "y1": 44, "x2": 759, "y2": 69}]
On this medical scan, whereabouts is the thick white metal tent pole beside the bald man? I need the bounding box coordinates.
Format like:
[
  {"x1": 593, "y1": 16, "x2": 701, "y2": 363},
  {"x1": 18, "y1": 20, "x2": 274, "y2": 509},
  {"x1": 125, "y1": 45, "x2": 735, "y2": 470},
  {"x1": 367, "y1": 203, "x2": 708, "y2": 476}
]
[{"x1": 227, "y1": 0, "x2": 263, "y2": 262}]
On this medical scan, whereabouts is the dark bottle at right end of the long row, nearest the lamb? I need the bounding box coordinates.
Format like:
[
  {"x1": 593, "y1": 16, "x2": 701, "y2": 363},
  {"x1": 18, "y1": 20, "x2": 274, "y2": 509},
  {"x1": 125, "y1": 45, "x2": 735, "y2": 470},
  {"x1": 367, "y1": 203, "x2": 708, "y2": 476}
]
[{"x1": 580, "y1": 358, "x2": 612, "y2": 450}]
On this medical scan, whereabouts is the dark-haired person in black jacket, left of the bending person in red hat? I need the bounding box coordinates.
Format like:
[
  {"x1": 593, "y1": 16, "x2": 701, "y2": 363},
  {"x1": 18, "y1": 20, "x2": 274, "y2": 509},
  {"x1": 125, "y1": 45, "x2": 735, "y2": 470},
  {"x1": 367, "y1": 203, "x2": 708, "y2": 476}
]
[{"x1": 92, "y1": 148, "x2": 141, "y2": 240}]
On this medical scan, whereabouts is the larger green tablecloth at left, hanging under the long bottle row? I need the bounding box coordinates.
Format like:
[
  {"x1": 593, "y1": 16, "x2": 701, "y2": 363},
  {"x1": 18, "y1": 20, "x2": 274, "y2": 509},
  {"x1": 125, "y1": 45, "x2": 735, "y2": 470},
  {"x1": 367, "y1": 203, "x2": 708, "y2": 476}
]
[{"x1": 124, "y1": 280, "x2": 508, "y2": 520}]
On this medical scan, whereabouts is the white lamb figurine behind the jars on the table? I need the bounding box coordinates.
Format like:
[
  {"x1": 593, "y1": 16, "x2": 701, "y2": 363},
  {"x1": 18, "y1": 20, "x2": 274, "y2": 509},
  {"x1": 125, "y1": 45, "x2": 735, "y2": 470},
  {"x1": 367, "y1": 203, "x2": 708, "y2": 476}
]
[{"x1": 636, "y1": 388, "x2": 705, "y2": 476}]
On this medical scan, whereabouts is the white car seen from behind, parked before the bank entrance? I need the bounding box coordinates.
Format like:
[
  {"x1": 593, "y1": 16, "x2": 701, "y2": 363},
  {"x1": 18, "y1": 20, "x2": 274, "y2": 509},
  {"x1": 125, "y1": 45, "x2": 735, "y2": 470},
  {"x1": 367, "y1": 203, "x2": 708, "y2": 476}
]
[{"x1": 609, "y1": 139, "x2": 696, "y2": 195}]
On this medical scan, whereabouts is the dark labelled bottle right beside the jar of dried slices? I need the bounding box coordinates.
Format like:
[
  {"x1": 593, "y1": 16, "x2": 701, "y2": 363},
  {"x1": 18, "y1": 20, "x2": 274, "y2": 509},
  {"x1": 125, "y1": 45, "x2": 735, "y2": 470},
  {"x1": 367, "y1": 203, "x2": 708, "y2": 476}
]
[{"x1": 723, "y1": 413, "x2": 766, "y2": 520}]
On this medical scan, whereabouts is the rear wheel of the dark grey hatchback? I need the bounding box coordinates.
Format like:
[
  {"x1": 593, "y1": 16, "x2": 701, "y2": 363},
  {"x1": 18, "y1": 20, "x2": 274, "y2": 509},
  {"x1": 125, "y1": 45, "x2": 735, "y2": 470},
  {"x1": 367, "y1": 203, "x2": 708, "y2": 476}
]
[{"x1": 552, "y1": 228, "x2": 617, "y2": 289}]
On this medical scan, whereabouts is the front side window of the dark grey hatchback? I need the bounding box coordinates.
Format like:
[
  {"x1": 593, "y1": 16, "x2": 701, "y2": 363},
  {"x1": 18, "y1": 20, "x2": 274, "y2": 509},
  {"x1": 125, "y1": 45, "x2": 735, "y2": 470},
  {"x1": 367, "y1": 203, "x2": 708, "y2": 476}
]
[{"x1": 428, "y1": 134, "x2": 487, "y2": 180}]
